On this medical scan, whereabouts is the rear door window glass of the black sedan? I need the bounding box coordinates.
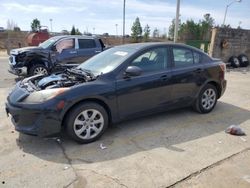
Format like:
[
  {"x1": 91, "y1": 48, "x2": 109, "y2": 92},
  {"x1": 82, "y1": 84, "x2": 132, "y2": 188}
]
[{"x1": 173, "y1": 47, "x2": 194, "y2": 68}]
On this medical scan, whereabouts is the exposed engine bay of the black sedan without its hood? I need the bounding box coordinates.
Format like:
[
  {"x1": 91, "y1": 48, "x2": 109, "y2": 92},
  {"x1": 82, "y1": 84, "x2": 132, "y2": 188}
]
[{"x1": 20, "y1": 68, "x2": 96, "y2": 92}]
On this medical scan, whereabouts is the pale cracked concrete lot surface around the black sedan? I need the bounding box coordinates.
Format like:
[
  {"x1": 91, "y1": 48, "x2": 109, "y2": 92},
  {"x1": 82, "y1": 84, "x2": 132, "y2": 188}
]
[{"x1": 0, "y1": 56, "x2": 250, "y2": 188}]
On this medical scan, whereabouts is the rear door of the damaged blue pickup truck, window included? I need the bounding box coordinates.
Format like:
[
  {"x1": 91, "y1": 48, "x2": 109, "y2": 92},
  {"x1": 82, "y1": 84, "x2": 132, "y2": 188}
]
[{"x1": 77, "y1": 39, "x2": 102, "y2": 63}]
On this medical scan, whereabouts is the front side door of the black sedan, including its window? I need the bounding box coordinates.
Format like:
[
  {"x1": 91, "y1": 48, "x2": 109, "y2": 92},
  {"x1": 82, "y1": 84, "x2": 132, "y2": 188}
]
[{"x1": 116, "y1": 47, "x2": 171, "y2": 118}]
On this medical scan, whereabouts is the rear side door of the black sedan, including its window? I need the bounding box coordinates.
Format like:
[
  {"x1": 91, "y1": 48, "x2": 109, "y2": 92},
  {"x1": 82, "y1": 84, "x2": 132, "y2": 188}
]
[{"x1": 171, "y1": 46, "x2": 206, "y2": 105}]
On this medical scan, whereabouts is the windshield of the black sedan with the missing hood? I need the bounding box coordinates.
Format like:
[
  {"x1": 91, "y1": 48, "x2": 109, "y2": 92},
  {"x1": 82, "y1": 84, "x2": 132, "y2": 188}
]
[{"x1": 77, "y1": 47, "x2": 135, "y2": 75}]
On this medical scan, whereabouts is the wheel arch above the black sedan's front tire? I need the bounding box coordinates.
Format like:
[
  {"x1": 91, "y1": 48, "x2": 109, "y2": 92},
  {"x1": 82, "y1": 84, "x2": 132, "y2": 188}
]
[{"x1": 62, "y1": 98, "x2": 112, "y2": 127}]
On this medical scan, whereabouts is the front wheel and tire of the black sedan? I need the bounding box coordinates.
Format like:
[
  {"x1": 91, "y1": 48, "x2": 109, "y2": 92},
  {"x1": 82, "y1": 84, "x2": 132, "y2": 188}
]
[{"x1": 65, "y1": 102, "x2": 109, "y2": 144}]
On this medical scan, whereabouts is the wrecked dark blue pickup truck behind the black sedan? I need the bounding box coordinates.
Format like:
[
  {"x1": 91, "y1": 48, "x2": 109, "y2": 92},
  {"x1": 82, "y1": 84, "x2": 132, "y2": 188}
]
[{"x1": 9, "y1": 35, "x2": 106, "y2": 76}]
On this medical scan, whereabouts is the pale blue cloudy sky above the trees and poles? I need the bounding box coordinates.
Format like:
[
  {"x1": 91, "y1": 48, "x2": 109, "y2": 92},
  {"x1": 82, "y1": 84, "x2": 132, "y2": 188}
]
[{"x1": 0, "y1": 0, "x2": 250, "y2": 34}]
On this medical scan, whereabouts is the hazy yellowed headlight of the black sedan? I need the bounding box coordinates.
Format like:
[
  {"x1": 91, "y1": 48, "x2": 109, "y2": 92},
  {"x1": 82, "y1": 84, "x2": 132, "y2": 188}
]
[{"x1": 22, "y1": 88, "x2": 69, "y2": 103}]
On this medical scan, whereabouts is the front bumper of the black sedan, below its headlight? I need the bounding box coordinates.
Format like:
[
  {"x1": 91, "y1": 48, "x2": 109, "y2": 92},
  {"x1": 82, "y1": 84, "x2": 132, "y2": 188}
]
[{"x1": 5, "y1": 102, "x2": 61, "y2": 137}]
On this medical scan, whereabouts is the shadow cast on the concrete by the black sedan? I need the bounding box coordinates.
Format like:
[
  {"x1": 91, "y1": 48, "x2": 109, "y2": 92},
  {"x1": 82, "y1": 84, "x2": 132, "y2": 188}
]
[{"x1": 16, "y1": 102, "x2": 250, "y2": 164}]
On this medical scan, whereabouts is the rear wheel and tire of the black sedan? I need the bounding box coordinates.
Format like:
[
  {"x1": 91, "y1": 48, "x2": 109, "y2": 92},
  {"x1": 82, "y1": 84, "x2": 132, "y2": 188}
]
[{"x1": 193, "y1": 84, "x2": 218, "y2": 114}]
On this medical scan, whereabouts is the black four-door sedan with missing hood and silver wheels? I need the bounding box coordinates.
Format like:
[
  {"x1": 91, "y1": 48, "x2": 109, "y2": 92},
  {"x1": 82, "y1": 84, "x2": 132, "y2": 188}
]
[{"x1": 6, "y1": 43, "x2": 226, "y2": 143}]
